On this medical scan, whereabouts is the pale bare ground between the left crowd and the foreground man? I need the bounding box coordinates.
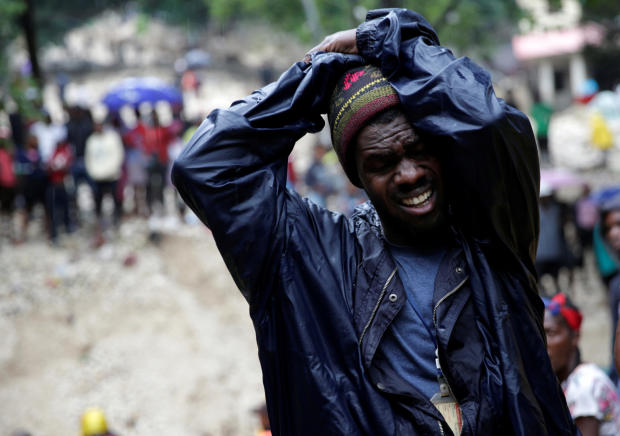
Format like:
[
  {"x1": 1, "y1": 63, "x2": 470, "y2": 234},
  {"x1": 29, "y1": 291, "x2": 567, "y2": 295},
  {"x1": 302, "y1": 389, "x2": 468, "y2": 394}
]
[{"x1": 0, "y1": 219, "x2": 264, "y2": 436}]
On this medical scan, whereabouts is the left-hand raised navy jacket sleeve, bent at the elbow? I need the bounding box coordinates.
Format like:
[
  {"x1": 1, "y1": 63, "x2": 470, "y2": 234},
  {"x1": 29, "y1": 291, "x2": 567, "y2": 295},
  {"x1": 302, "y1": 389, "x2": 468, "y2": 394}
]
[{"x1": 172, "y1": 53, "x2": 361, "y2": 305}]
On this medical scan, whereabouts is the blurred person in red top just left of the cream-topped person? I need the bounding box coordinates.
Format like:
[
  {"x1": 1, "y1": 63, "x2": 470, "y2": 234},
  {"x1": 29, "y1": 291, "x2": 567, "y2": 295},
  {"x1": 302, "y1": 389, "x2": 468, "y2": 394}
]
[{"x1": 45, "y1": 140, "x2": 74, "y2": 244}]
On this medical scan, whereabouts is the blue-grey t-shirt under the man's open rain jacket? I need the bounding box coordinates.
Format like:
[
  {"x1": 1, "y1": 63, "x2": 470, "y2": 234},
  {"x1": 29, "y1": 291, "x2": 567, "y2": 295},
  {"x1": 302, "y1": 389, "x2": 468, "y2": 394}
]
[{"x1": 376, "y1": 244, "x2": 446, "y2": 399}]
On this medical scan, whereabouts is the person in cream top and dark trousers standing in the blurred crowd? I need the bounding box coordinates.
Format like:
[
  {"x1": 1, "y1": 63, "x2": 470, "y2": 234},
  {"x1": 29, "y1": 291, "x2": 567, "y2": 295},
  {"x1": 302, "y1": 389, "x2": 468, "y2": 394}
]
[{"x1": 84, "y1": 123, "x2": 124, "y2": 239}]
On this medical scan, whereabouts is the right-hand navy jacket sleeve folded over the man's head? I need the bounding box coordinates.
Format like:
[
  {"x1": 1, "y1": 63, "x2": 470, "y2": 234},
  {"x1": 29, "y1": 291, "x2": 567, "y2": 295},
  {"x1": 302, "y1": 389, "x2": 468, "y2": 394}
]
[{"x1": 357, "y1": 9, "x2": 540, "y2": 271}]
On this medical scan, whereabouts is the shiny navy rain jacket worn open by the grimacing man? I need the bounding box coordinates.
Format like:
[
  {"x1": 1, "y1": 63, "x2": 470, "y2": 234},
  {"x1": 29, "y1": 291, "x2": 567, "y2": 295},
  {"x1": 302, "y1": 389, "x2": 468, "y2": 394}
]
[{"x1": 173, "y1": 10, "x2": 575, "y2": 436}]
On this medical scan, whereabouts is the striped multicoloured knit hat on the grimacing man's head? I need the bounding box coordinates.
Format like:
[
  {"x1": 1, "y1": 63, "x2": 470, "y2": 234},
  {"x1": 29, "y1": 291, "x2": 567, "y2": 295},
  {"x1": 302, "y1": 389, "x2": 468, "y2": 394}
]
[{"x1": 327, "y1": 65, "x2": 400, "y2": 186}]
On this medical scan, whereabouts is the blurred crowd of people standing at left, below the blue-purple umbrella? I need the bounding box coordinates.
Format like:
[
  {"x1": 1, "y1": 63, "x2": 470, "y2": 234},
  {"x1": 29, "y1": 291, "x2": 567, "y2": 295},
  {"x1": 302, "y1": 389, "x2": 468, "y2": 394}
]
[{"x1": 0, "y1": 100, "x2": 201, "y2": 244}]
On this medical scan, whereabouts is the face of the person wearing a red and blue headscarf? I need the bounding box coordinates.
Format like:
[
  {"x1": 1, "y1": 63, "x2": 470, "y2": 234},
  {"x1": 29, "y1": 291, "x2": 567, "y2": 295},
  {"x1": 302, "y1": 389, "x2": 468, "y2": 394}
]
[{"x1": 544, "y1": 310, "x2": 579, "y2": 375}]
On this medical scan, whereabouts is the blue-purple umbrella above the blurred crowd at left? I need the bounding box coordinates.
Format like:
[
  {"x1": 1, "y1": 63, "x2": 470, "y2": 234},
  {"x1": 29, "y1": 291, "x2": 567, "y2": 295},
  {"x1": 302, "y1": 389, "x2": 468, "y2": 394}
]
[{"x1": 102, "y1": 77, "x2": 183, "y2": 111}]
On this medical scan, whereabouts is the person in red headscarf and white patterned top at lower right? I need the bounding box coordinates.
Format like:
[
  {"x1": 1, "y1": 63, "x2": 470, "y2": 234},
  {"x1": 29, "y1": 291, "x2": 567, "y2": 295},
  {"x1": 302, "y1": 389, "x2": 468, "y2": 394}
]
[{"x1": 544, "y1": 293, "x2": 620, "y2": 436}]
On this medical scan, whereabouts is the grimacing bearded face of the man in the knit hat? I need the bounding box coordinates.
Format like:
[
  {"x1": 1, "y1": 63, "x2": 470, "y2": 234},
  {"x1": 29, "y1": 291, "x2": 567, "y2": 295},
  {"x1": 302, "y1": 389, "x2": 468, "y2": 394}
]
[{"x1": 355, "y1": 114, "x2": 444, "y2": 245}]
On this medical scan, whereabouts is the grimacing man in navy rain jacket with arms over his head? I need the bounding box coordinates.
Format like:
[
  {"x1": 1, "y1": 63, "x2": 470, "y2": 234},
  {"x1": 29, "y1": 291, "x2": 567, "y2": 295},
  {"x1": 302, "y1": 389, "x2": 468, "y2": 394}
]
[{"x1": 173, "y1": 9, "x2": 574, "y2": 435}]
